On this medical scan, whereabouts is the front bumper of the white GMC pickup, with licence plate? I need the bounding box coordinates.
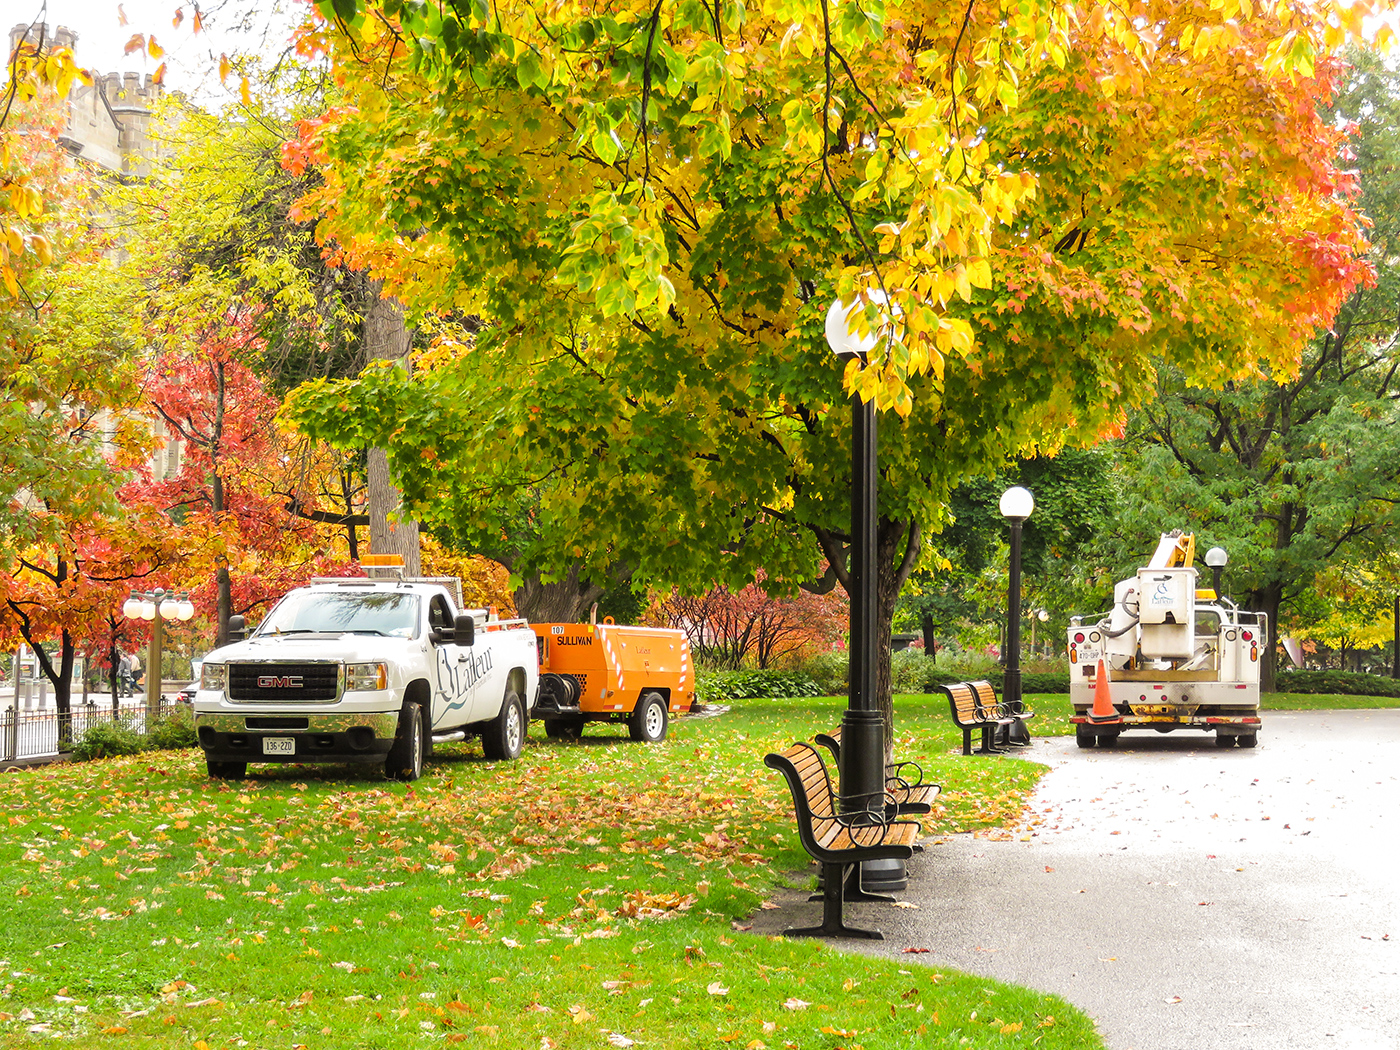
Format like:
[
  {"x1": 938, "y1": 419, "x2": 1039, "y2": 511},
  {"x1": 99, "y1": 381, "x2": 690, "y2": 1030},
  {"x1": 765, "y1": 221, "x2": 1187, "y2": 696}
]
[{"x1": 195, "y1": 713, "x2": 399, "y2": 762}]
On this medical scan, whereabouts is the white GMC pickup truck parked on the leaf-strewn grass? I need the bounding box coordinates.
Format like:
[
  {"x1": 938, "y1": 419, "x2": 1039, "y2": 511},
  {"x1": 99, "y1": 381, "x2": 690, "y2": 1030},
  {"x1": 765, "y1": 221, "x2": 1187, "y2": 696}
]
[{"x1": 193, "y1": 578, "x2": 539, "y2": 780}]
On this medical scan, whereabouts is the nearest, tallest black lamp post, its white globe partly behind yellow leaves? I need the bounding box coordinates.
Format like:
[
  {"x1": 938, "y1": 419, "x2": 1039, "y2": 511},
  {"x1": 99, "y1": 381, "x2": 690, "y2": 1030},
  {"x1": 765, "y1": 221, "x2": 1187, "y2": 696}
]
[{"x1": 826, "y1": 291, "x2": 909, "y2": 900}]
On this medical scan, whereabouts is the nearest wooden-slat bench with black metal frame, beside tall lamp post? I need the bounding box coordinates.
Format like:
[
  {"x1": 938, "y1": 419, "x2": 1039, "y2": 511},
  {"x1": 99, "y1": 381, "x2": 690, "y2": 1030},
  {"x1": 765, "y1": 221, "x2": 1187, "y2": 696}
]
[{"x1": 763, "y1": 742, "x2": 921, "y2": 941}]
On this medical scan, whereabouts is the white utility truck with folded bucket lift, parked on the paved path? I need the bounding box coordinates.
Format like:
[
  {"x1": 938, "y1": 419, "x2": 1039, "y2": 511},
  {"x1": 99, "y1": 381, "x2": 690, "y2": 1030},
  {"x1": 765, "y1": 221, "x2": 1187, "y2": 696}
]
[{"x1": 1068, "y1": 532, "x2": 1268, "y2": 748}]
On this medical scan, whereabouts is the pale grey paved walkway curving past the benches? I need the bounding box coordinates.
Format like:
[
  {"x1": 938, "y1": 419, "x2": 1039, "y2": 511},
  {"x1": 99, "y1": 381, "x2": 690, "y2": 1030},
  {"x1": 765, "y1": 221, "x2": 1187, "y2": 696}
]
[{"x1": 753, "y1": 710, "x2": 1400, "y2": 1050}]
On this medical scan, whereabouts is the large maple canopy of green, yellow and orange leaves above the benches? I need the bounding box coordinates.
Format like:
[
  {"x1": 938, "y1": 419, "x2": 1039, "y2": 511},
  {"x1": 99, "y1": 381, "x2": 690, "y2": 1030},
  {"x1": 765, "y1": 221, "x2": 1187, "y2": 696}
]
[{"x1": 288, "y1": 0, "x2": 1368, "y2": 733}]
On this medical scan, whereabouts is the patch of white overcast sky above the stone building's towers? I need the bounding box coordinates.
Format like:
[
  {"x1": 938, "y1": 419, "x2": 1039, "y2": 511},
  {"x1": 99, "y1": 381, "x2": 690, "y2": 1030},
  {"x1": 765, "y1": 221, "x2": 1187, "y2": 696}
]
[{"x1": 15, "y1": 0, "x2": 305, "y2": 95}]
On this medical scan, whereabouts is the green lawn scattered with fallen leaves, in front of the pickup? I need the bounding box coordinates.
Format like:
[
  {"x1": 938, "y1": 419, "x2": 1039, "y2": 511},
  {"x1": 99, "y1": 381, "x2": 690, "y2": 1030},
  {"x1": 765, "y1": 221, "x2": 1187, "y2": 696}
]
[{"x1": 0, "y1": 697, "x2": 1102, "y2": 1050}]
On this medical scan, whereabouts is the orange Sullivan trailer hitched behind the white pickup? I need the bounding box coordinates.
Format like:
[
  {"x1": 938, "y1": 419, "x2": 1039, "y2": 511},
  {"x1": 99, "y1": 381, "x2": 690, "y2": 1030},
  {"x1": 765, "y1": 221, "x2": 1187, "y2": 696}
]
[{"x1": 531, "y1": 617, "x2": 696, "y2": 742}]
